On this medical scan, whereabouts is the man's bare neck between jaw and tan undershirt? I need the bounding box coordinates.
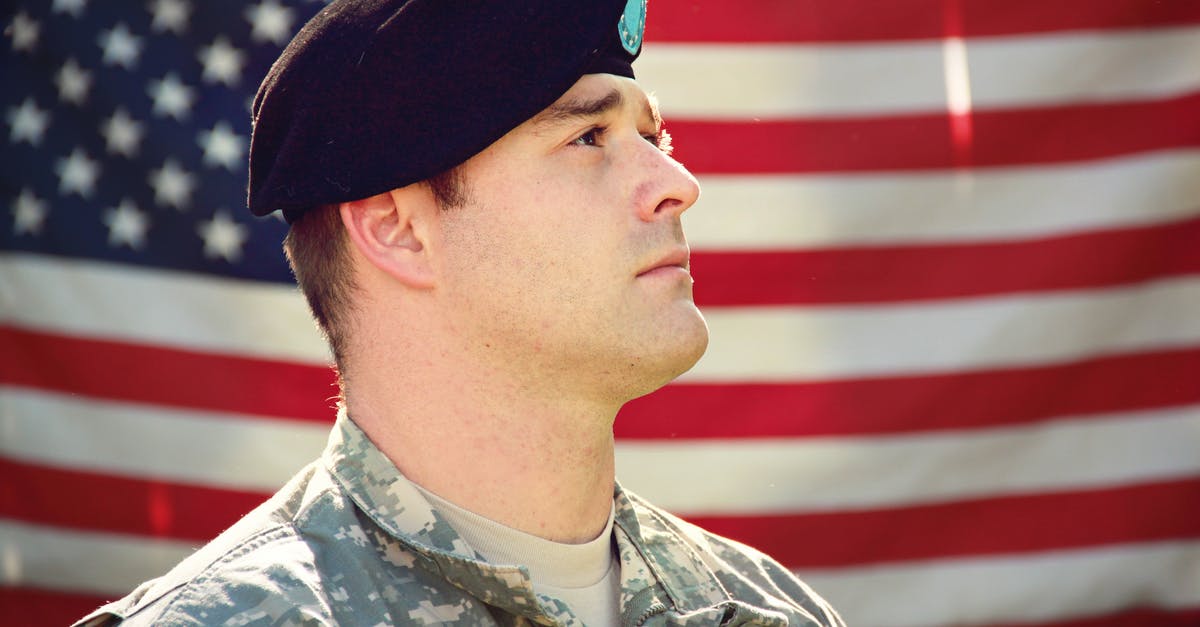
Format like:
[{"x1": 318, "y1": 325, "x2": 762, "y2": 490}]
[{"x1": 346, "y1": 350, "x2": 619, "y2": 543}]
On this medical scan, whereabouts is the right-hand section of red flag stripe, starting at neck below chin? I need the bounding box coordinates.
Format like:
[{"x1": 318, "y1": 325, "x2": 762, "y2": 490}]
[{"x1": 616, "y1": 346, "x2": 1200, "y2": 440}]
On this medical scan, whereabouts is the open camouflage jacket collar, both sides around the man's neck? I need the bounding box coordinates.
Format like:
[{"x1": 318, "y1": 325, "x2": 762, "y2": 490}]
[{"x1": 323, "y1": 410, "x2": 730, "y2": 623}]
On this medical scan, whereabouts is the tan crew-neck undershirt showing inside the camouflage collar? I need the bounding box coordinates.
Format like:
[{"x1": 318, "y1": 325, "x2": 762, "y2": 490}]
[{"x1": 414, "y1": 484, "x2": 620, "y2": 627}]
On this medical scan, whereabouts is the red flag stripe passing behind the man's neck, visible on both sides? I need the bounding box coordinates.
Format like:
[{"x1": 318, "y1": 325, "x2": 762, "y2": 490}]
[{"x1": 0, "y1": 328, "x2": 1200, "y2": 440}]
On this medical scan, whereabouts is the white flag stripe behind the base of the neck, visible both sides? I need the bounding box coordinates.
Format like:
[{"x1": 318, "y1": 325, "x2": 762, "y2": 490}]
[{"x1": 11, "y1": 388, "x2": 1200, "y2": 514}]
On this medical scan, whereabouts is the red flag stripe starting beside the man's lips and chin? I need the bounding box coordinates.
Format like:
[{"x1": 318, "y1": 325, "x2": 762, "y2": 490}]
[{"x1": 692, "y1": 217, "x2": 1200, "y2": 305}]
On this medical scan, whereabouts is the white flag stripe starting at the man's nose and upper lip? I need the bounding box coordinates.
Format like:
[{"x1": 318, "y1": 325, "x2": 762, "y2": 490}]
[{"x1": 683, "y1": 148, "x2": 1200, "y2": 250}]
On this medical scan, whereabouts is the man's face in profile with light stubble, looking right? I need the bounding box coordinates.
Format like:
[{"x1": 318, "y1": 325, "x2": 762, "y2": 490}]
[{"x1": 440, "y1": 74, "x2": 708, "y2": 402}]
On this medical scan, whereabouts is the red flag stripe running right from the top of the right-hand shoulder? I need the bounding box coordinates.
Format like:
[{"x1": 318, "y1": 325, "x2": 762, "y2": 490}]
[{"x1": 686, "y1": 477, "x2": 1200, "y2": 569}]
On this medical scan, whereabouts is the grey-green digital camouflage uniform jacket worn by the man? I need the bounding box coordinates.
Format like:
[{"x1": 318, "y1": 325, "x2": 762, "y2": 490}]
[{"x1": 77, "y1": 413, "x2": 842, "y2": 626}]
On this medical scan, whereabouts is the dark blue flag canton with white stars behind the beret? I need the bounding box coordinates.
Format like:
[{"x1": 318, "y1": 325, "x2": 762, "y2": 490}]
[{"x1": 0, "y1": 0, "x2": 324, "y2": 281}]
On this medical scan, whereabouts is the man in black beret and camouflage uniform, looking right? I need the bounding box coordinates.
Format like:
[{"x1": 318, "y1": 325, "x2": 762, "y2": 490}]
[{"x1": 80, "y1": 0, "x2": 841, "y2": 626}]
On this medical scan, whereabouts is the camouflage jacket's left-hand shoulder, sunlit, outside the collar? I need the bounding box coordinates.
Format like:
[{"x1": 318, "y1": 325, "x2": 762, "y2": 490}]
[{"x1": 70, "y1": 473, "x2": 480, "y2": 627}]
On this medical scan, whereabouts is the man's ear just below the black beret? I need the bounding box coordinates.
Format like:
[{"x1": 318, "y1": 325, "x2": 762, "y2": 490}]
[{"x1": 338, "y1": 185, "x2": 437, "y2": 289}]
